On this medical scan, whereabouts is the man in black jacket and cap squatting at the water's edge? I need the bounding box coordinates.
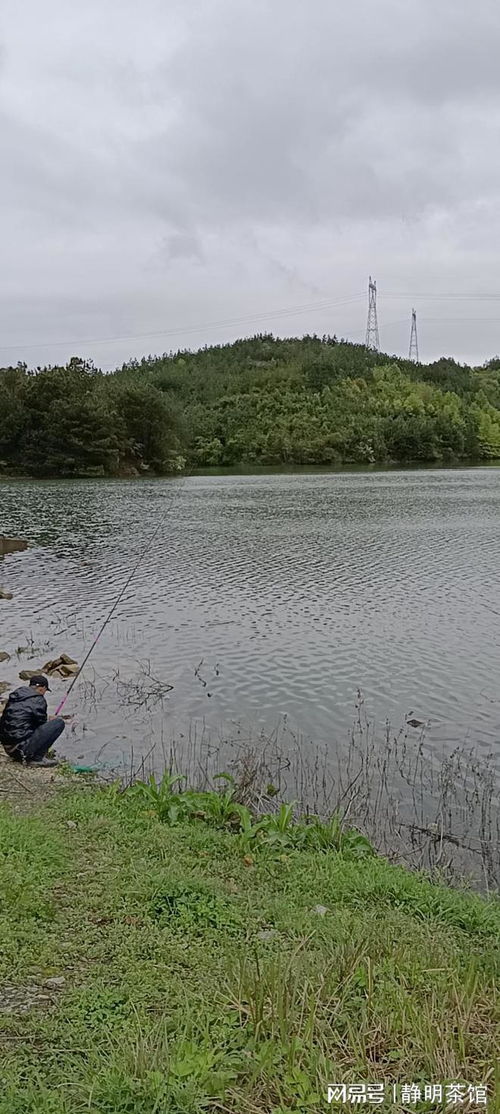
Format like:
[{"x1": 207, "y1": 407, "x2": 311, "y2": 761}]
[{"x1": 0, "y1": 673, "x2": 66, "y2": 766}]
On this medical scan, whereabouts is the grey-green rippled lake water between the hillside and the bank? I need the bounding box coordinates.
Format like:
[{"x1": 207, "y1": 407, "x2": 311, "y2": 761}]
[{"x1": 0, "y1": 468, "x2": 500, "y2": 758}]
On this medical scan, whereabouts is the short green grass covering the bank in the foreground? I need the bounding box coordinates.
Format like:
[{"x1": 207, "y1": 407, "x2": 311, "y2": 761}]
[{"x1": 0, "y1": 788, "x2": 500, "y2": 1114}]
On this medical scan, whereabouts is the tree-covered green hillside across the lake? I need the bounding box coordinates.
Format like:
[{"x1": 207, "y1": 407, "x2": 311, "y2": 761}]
[{"x1": 0, "y1": 335, "x2": 500, "y2": 476}]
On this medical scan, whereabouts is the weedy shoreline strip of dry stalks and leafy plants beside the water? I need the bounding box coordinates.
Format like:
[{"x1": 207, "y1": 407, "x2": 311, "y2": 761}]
[{"x1": 0, "y1": 735, "x2": 500, "y2": 898}]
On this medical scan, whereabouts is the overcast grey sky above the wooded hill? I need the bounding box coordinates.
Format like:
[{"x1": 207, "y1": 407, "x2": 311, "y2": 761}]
[{"x1": 0, "y1": 0, "x2": 500, "y2": 368}]
